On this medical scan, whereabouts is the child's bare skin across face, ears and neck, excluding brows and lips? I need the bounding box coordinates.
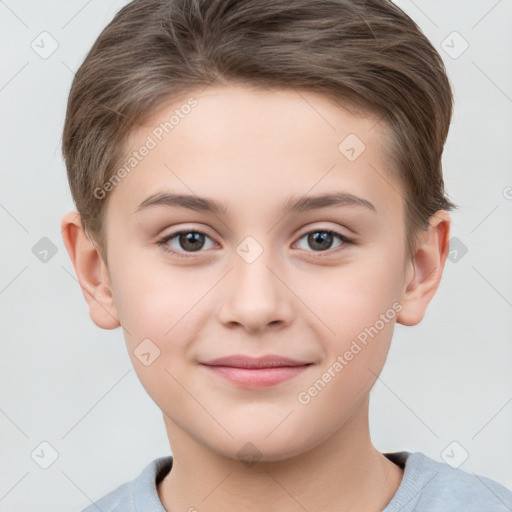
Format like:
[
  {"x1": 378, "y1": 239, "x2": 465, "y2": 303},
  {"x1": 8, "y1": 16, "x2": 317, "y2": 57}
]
[{"x1": 61, "y1": 84, "x2": 450, "y2": 512}]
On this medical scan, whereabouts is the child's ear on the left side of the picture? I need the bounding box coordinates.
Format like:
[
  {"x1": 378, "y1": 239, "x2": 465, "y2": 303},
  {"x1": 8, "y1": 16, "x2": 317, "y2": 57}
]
[{"x1": 61, "y1": 212, "x2": 121, "y2": 329}]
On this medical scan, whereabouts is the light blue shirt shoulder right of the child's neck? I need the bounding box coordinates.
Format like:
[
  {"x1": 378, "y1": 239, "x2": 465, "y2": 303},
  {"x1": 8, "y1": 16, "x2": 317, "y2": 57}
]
[{"x1": 385, "y1": 452, "x2": 512, "y2": 512}]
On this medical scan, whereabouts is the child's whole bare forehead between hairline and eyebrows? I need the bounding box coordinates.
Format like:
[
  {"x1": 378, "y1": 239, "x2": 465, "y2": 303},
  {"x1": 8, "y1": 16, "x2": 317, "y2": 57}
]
[{"x1": 109, "y1": 85, "x2": 401, "y2": 223}]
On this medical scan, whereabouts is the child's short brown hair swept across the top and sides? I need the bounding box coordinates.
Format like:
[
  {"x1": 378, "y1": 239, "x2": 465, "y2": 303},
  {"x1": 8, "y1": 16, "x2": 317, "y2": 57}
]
[{"x1": 62, "y1": 0, "x2": 455, "y2": 262}]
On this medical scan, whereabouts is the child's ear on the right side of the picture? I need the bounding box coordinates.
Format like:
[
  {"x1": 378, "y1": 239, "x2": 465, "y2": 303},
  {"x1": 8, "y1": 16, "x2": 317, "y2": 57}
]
[{"x1": 396, "y1": 210, "x2": 451, "y2": 325}]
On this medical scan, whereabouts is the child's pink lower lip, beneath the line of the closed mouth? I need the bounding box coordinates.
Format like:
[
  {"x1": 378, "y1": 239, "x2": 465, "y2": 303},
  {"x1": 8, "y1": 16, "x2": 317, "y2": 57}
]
[{"x1": 204, "y1": 365, "x2": 309, "y2": 388}]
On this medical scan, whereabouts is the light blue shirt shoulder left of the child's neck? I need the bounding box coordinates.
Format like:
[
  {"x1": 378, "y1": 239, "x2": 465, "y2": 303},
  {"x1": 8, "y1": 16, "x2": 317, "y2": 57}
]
[{"x1": 82, "y1": 456, "x2": 172, "y2": 512}]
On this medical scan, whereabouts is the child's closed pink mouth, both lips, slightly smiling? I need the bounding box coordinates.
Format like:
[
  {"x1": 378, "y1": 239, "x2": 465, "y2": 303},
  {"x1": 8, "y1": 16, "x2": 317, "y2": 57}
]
[{"x1": 200, "y1": 355, "x2": 313, "y2": 389}]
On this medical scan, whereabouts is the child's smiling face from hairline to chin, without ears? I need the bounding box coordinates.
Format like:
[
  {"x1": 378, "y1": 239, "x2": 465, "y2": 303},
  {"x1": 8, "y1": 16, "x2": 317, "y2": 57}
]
[{"x1": 101, "y1": 86, "x2": 412, "y2": 460}]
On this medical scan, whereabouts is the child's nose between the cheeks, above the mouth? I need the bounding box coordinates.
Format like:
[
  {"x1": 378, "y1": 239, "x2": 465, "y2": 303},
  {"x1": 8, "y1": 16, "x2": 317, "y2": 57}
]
[{"x1": 217, "y1": 246, "x2": 293, "y2": 333}]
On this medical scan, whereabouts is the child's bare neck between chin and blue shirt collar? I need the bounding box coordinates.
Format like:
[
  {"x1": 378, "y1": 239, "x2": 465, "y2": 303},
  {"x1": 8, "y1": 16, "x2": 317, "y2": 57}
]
[{"x1": 158, "y1": 400, "x2": 403, "y2": 512}]
